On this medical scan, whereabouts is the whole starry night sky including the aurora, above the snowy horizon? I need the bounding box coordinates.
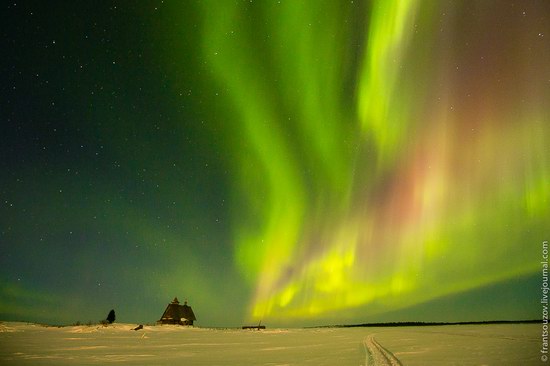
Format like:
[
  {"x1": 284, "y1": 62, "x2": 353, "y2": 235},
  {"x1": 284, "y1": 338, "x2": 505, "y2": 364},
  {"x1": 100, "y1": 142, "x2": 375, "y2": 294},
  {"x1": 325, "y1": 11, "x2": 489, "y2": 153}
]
[{"x1": 0, "y1": 0, "x2": 550, "y2": 326}]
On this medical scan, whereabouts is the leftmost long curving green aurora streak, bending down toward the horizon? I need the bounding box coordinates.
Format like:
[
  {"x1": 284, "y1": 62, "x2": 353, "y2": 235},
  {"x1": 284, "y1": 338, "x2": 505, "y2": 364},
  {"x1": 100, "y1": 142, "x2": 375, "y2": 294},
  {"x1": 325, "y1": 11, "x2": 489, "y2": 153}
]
[{"x1": 201, "y1": 2, "x2": 304, "y2": 284}]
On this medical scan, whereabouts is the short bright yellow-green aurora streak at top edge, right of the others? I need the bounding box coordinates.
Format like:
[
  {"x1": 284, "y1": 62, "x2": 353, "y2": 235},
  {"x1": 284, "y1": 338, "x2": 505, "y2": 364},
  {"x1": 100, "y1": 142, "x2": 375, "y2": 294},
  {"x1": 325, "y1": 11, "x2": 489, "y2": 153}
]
[{"x1": 358, "y1": 0, "x2": 417, "y2": 161}]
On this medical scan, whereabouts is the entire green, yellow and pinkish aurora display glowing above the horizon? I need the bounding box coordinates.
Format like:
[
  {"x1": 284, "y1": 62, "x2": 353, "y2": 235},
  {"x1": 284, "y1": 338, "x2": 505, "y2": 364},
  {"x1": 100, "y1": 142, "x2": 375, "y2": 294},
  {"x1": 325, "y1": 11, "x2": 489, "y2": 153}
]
[{"x1": 203, "y1": 0, "x2": 550, "y2": 320}]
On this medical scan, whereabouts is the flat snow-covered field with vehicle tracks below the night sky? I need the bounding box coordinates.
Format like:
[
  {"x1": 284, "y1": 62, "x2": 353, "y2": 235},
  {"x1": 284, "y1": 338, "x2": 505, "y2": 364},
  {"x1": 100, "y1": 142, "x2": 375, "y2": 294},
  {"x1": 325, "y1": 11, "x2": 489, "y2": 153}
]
[{"x1": 0, "y1": 322, "x2": 543, "y2": 366}]
